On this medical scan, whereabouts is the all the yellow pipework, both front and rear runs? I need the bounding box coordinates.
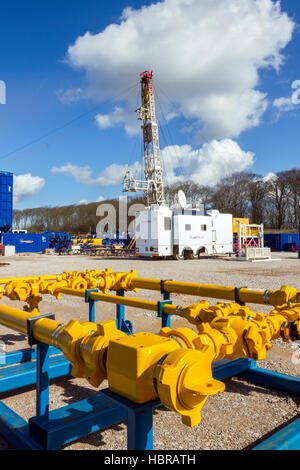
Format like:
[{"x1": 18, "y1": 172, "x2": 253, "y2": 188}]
[{"x1": 0, "y1": 269, "x2": 300, "y2": 426}]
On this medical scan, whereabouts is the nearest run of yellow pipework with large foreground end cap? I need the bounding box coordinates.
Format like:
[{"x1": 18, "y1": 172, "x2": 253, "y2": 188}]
[{"x1": 0, "y1": 305, "x2": 300, "y2": 426}]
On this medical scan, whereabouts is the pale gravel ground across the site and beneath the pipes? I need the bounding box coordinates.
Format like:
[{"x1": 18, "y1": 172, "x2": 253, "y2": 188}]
[{"x1": 0, "y1": 253, "x2": 300, "y2": 450}]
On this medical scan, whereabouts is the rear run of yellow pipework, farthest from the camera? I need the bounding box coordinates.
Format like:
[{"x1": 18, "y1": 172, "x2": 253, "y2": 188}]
[{"x1": 0, "y1": 269, "x2": 300, "y2": 310}]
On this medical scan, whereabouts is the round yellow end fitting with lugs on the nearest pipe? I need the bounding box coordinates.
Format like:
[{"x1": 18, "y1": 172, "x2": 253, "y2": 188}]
[{"x1": 154, "y1": 347, "x2": 225, "y2": 427}]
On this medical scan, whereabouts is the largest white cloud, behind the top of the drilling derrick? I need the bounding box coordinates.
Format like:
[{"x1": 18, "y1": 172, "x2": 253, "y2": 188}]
[{"x1": 67, "y1": 0, "x2": 294, "y2": 140}]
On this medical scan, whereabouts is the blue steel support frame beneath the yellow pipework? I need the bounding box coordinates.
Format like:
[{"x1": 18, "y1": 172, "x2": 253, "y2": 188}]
[{"x1": 0, "y1": 289, "x2": 300, "y2": 450}]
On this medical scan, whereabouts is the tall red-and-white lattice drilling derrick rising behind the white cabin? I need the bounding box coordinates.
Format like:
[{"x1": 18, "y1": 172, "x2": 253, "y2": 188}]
[{"x1": 123, "y1": 71, "x2": 164, "y2": 207}]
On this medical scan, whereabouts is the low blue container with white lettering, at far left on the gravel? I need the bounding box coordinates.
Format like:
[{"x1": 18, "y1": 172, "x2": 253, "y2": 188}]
[{"x1": 1, "y1": 233, "x2": 49, "y2": 253}]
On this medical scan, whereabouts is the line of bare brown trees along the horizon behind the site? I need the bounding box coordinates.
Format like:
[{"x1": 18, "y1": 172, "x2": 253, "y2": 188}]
[{"x1": 14, "y1": 168, "x2": 300, "y2": 234}]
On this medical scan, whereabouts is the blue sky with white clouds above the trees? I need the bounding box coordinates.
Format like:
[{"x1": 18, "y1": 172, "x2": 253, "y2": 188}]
[{"x1": 0, "y1": 0, "x2": 300, "y2": 208}]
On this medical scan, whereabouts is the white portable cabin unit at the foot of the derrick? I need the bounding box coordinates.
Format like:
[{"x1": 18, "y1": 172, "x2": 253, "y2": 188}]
[{"x1": 135, "y1": 206, "x2": 233, "y2": 259}]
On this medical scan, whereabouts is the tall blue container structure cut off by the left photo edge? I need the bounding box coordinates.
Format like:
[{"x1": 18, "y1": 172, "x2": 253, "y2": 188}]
[{"x1": 0, "y1": 171, "x2": 13, "y2": 232}]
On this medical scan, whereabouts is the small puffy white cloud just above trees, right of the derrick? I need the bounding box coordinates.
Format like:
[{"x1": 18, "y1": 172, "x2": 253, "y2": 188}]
[{"x1": 162, "y1": 139, "x2": 254, "y2": 186}]
